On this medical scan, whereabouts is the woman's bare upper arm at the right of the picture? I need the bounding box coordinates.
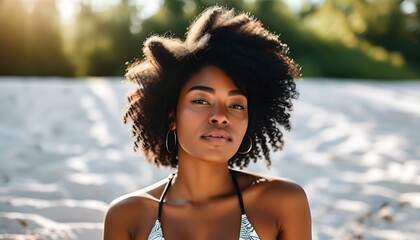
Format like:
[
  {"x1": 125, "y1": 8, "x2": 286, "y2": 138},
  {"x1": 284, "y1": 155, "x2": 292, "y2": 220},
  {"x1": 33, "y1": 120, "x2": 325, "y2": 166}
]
[{"x1": 277, "y1": 183, "x2": 312, "y2": 240}]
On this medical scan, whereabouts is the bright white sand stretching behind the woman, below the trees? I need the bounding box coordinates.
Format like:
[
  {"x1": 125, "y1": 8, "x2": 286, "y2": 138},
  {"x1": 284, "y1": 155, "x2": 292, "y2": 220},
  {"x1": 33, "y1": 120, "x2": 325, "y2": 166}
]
[{"x1": 0, "y1": 77, "x2": 420, "y2": 240}]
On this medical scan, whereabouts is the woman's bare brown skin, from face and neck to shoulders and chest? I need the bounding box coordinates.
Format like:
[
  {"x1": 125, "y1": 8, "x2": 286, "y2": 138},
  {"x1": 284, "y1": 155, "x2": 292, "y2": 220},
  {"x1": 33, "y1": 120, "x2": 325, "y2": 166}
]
[{"x1": 104, "y1": 66, "x2": 311, "y2": 240}]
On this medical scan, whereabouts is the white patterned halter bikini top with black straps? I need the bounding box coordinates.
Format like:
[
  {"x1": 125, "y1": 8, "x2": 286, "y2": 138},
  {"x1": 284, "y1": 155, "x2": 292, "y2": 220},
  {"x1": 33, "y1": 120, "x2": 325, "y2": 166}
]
[{"x1": 147, "y1": 170, "x2": 260, "y2": 240}]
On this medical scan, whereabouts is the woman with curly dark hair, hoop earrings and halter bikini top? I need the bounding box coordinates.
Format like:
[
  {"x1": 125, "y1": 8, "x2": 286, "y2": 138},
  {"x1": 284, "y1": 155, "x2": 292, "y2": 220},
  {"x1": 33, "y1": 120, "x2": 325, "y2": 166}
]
[{"x1": 104, "y1": 7, "x2": 311, "y2": 240}]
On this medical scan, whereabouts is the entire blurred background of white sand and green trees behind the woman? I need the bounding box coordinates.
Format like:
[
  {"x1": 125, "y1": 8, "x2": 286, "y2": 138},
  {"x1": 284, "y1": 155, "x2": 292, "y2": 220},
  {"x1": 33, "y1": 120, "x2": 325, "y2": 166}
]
[{"x1": 0, "y1": 0, "x2": 420, "y2": 240}]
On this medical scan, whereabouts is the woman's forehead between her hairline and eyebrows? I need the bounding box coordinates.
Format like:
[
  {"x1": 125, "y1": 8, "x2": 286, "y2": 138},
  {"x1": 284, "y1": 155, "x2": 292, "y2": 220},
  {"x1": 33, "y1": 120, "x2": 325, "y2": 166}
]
[{"x1": 181, "y1": 65, "x2": 239, "y2": 92}]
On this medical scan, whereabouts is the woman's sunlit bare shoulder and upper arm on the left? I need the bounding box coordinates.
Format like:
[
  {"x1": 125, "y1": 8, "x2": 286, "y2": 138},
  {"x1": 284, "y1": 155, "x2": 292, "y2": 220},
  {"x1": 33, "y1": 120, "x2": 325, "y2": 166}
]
[{"x1": 104, "y1": 179, "x2": 166, "y2": 239}]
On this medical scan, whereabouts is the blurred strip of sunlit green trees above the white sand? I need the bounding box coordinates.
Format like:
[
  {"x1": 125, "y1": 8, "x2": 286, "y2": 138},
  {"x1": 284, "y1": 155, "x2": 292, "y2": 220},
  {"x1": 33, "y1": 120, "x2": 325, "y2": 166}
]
[{"x1": 0, "y1": 0, "x2": 420, "y2": 80}]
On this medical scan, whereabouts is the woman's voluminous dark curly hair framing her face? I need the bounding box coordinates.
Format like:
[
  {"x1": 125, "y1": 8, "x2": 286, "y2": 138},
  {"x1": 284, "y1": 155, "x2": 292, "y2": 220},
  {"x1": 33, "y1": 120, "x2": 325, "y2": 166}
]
[{"x1": 124, "y1": 6, "x2": 300, "y2": 168}]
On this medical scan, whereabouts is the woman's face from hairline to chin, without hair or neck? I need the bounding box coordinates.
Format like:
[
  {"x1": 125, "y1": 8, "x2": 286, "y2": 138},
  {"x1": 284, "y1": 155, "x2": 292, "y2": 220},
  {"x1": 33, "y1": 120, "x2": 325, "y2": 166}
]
[{"x1": 173, "y1": 66, "x2": 248, "y2": 163}]
